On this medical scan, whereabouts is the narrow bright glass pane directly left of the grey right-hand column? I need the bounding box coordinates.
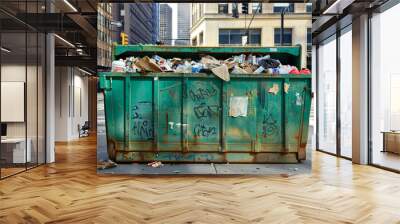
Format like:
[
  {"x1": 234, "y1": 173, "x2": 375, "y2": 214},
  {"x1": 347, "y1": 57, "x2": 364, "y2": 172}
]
[{"x1": 340, "y1": 31, "x2": 353, "y2": 158}]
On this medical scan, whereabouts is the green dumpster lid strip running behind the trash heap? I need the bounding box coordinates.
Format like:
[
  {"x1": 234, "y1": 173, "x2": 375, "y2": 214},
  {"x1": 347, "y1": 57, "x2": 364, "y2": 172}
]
[{"x1": 114, "y1": 45, "x2": 301, "y2": 68}]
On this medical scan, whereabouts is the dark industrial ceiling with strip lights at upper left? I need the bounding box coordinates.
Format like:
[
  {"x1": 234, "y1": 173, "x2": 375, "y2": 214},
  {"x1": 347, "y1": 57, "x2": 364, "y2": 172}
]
[{"x1": 0, "y1": 0, "x2": 97, "y2": 71}]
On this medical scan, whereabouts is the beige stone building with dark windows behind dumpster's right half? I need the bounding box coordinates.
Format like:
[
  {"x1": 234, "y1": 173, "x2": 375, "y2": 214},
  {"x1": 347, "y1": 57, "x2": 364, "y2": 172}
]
[{"x1": 190, "y1": 3, "x2": 312, "y2": 67}]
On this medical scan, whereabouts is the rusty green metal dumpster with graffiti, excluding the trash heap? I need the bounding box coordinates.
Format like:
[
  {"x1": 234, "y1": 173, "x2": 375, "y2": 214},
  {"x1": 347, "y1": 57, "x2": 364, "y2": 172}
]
[{"x1": 99, "y1": 45, "x2": 311, "y2": 163}]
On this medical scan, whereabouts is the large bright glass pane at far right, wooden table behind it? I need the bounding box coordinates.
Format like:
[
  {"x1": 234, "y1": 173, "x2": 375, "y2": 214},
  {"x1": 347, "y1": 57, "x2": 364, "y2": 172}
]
[{"x1": 371, "y1": 4, "x2": 400, "y2": 170}]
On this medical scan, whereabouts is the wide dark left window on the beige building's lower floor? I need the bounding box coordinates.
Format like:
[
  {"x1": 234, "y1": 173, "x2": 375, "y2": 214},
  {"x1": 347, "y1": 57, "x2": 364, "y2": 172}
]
[{"x1": 219, "y1": 29, "x2": 261, "y2": 45}]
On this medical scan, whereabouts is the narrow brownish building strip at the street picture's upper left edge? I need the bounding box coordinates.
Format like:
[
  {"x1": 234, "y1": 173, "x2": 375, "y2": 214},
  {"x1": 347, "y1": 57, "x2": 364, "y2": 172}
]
[{"x1": 97, "y1": 3, "x2": 113, "y2": 68}]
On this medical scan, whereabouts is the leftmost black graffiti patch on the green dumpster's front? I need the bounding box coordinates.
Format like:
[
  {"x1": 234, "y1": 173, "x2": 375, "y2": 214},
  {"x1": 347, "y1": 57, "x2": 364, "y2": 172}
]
[{"x1": 131, "y1": 101, "x2": 153, "y2": 139}]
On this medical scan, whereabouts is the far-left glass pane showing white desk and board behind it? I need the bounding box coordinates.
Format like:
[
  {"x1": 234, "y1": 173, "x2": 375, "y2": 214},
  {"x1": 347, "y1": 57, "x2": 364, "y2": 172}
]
[{"x1": 0, "y1": 30, "x2": 27, "y2": 177}]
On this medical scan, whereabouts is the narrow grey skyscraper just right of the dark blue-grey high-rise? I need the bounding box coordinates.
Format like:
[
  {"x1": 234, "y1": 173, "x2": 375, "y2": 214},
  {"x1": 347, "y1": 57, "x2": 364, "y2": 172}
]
[{"x1": 159, "y1": 4, "x2": 172, "y2": 45}]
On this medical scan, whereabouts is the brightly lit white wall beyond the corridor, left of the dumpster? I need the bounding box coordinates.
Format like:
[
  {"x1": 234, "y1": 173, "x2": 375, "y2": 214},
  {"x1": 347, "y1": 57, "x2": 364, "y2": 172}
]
[{"x1": 55, "y1": 67, "x2": 88, "y2": 141}]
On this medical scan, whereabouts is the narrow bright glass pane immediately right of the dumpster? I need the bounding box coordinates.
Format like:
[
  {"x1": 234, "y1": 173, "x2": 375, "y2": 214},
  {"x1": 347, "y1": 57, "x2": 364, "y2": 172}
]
[{"x1": 317, "y1": 40, "x2": 336, "y2": 154}]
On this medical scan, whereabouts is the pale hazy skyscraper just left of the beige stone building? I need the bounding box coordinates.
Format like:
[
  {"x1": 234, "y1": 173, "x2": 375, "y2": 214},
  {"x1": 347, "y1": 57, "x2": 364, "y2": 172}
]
[{"x1": 175, "y1": 3, "x2": 190, "y2": 45}]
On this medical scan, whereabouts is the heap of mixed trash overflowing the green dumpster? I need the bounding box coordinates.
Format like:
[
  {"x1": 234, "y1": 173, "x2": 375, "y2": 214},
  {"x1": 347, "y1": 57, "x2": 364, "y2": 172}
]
[{"x1": 112, "y1": 54, "x2": 311, "y2": 81}]
